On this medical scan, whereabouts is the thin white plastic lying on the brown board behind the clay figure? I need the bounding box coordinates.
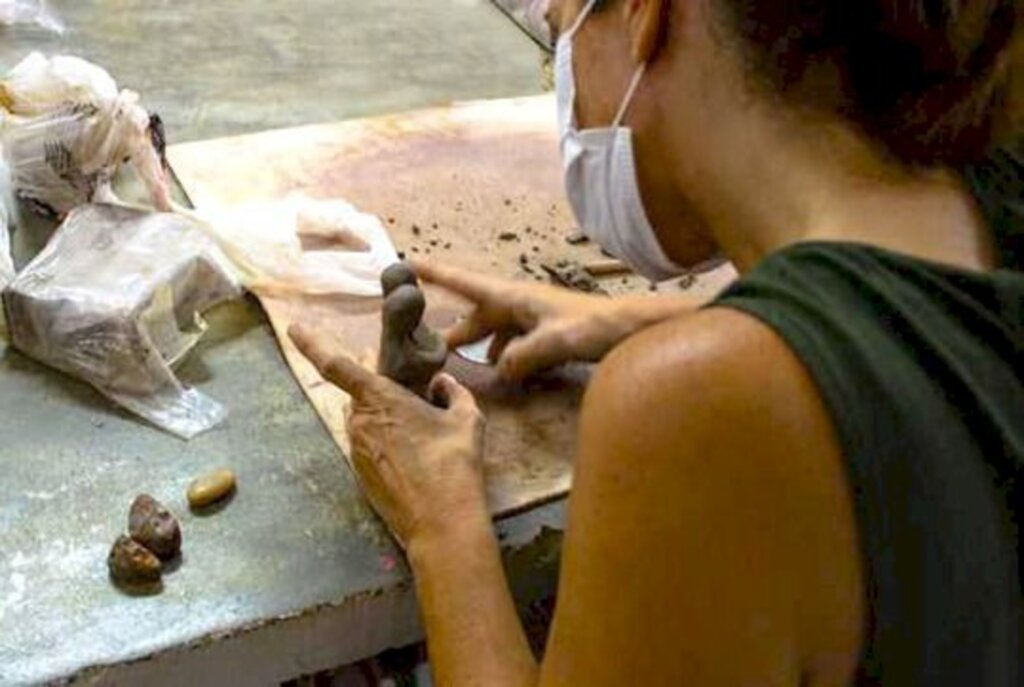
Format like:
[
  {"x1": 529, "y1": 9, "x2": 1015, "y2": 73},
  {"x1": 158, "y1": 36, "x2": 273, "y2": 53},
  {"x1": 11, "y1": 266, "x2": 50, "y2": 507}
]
[{"x1": 188, "y1": 196, "x2": 398, "y2": 296}]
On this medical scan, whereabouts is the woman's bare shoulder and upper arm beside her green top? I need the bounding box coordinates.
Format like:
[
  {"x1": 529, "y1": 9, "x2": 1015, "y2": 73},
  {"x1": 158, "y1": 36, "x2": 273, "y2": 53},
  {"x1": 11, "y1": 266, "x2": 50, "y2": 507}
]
[{"x1": 551, "y1": 309, "x2": 861, "y2": 684}]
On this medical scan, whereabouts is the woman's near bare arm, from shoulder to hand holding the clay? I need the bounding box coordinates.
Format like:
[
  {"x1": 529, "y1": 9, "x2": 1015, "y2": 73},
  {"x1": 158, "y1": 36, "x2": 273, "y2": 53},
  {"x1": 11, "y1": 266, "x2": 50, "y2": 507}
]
[{"x1": 295, "y1": 309, "x2": 863, "y2": 687}]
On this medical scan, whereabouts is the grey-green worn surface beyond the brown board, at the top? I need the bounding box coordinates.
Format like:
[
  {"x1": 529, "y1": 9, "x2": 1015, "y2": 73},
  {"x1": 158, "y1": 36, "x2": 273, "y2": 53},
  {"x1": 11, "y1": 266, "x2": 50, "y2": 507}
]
[{"x1": 0, "y1": 0, "x2": 542, "y2": 142}]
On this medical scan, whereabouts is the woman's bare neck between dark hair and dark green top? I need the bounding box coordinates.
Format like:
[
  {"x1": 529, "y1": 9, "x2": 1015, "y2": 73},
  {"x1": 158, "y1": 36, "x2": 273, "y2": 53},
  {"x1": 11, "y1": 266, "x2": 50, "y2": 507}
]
[{"x1": 667, "y1": 91, "x2": 995, "y2": 271}]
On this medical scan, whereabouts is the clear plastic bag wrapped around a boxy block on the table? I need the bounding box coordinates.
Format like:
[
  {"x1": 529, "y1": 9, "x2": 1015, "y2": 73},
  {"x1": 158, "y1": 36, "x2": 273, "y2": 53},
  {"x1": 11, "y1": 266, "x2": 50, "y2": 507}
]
[{"x1": 4, "y1": 205, "x2": 239, "y2": 438}]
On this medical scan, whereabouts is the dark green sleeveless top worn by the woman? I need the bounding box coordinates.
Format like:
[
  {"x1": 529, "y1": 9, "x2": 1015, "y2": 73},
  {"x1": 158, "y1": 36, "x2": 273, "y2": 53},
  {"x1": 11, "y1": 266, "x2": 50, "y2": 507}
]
[{"x1": 714, "y1": 243, "x2": 1024, "y2": 687}]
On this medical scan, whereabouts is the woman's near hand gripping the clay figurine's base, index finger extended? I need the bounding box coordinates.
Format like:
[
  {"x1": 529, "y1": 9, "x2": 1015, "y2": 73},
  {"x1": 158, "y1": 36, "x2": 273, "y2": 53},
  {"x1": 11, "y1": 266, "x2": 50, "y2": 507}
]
[{"x1": 289, "y1": 325, "x2": 486, "y2": 548}]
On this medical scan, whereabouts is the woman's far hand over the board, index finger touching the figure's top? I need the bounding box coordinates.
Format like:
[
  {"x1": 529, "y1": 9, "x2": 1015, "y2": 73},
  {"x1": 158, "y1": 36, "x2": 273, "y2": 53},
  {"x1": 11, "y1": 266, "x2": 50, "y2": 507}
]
[{"x1": 413, "y1": 261, "x2": 668, "y2": 381}]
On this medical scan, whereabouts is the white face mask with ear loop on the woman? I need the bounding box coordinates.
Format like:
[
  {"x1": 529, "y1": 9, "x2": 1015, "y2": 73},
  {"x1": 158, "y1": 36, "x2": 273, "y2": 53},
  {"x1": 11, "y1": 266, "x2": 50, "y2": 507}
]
[{"x1": 555, "y1": 0, "x2": 692, "y2": 281}]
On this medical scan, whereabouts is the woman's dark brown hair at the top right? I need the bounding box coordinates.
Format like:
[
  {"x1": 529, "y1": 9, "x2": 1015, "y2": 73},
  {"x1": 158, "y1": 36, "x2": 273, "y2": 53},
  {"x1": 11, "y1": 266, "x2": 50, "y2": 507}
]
[{"x1": 717, "y1": 0, "x2": 1024, "y2": 167}]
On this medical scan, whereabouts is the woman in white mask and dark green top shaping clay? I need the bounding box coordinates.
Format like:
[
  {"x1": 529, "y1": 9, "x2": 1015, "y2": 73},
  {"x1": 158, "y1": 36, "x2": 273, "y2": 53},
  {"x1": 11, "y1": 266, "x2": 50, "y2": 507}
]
[{"x1": 293, "y1": 0, "x2": 1024, "y2": 685}]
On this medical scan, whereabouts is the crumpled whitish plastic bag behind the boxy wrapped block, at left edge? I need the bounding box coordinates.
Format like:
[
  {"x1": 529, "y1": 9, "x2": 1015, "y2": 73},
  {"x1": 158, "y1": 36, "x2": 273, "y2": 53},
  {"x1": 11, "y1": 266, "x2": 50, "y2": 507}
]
[{"x1": 0, "y1": 52, "x2": 171, "y2": 217}]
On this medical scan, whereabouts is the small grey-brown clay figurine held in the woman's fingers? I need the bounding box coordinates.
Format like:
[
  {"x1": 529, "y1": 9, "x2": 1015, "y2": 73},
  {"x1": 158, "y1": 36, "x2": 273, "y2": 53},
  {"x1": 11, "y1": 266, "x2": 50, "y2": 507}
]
[{"x1": 377, "y1": 262, "x2": 449, "y2": 396}]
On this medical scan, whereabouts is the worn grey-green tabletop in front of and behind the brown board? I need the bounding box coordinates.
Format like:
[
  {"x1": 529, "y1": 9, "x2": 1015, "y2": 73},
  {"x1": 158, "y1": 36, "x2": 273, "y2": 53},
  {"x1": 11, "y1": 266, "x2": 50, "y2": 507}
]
[{"x1": 0, "y1": 0, "x2": 553, "y2": 685}]
